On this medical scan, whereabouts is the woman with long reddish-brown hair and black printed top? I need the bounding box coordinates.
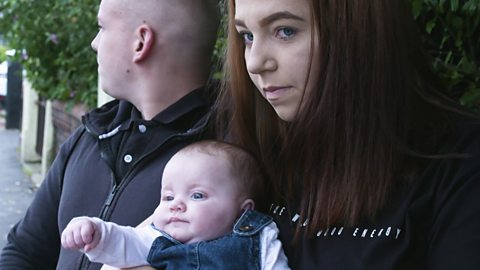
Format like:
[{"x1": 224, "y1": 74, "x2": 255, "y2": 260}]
[{"x1": 217, "y1": 0, "x2": 480, "y2": 269}]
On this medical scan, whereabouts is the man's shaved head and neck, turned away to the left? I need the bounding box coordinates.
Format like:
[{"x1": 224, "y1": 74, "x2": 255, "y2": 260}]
[{"x1": 92, "y1": 0, "x2": 220, "y2": 119}]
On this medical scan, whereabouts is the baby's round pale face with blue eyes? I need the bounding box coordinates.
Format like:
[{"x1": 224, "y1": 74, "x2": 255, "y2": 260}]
[{"x1": 153, "y1": 150, "x2": 245, "y2": 243}]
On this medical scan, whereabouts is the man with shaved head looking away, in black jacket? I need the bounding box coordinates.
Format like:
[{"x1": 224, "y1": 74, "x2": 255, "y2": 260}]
[{"x1": 0, "y1": 0, "x2": 219, "y2": 270}]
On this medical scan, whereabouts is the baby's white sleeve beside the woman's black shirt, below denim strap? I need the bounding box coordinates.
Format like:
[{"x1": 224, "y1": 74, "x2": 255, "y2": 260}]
[{"x1": 260, "y1": 222, "x2": 290, "y2": 270}]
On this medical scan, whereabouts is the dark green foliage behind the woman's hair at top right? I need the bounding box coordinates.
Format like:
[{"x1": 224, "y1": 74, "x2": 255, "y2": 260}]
[{"x1": 410, "y1": 0, "x2": 480, "y2": 112}]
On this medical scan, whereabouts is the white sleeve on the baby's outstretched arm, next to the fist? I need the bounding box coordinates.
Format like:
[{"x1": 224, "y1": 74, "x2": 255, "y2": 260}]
[{"x1": 85, "y1": 218, "x2": 162, "y2": 268}]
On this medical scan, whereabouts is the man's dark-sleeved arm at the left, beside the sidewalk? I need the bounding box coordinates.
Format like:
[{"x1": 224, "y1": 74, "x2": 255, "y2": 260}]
[{"x1": 0, "y1": 129, "x2": 82, "y2": 270}]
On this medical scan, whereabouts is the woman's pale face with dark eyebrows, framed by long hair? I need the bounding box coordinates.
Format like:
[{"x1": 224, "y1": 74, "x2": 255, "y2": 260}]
[{"x1": 235, "y1": 0, "x2": 318, "y2": 121}]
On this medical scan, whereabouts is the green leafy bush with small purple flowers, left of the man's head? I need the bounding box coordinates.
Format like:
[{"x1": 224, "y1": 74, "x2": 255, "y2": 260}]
[{"x1": 0, "y1": 0, "x2": 99, "y2": 107}]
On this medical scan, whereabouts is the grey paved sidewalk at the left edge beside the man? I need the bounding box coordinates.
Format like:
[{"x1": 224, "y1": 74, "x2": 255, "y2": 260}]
[{"x1": 0, "y1": 115, "x2": 34, "y2": 249}]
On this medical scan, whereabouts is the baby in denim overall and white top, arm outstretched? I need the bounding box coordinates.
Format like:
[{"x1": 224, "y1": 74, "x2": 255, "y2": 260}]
[{"x1": 62, "y1": 141, "x2": 289, "y2": 269}]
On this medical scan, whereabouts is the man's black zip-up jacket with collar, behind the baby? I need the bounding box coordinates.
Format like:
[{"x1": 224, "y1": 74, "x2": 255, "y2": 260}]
[{"x1": 0, "y1": 87, "x2": 213, "y2": 270}]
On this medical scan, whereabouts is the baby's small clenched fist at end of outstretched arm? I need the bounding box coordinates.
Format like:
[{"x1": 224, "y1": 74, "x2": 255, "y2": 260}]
[{"x1": 62, "y1": 217, "x2": 100, "y2": 252}]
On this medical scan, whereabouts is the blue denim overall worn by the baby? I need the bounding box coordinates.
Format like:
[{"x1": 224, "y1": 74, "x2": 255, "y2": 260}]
[{"x1": 147, "y1": 210, "x2": 272, "y2": 270}]
